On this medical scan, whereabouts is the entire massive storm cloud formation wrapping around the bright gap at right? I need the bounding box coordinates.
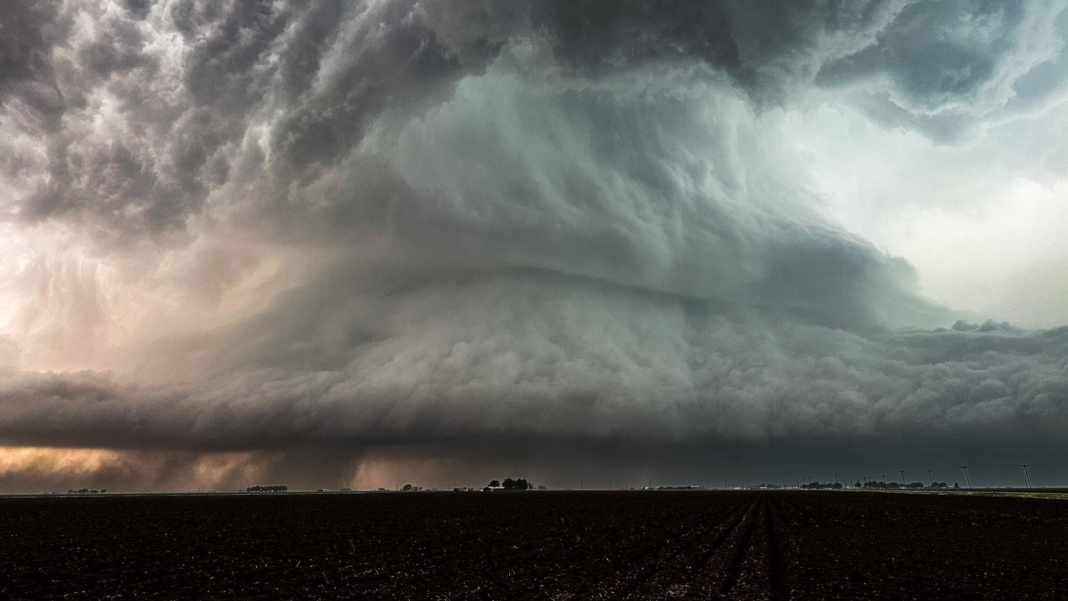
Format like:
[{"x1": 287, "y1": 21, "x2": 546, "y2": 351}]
[{"x1": 0, "y1": 0, "x2": 1068, "y2": 485}]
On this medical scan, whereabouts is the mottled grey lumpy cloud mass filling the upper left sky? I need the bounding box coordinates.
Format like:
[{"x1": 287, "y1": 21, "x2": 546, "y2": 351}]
[{"x1": 3, "y1": 0, "x2": 521, "y2": 234}]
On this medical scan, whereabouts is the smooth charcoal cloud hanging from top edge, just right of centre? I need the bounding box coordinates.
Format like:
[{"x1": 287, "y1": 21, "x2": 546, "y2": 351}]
[{"x1": 536, "y1": 0, "x2": 904, "y2": 100}]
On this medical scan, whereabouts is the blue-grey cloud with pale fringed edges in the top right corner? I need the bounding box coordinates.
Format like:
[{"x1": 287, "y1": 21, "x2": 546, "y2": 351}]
[{"x1": 816, "y1": 0, "x2": 1068, "y2": 141}]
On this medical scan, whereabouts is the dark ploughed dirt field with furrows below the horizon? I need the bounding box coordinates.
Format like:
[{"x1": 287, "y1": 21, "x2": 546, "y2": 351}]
[{"x1": 0, "y1": 492, "x2": 1068, "y2": 600}]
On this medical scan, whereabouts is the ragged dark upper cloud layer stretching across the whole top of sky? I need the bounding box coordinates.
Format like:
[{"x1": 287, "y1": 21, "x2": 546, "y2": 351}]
[{"x1": 3, "y1": 0, "x2": 1063, "y2": 233}]
